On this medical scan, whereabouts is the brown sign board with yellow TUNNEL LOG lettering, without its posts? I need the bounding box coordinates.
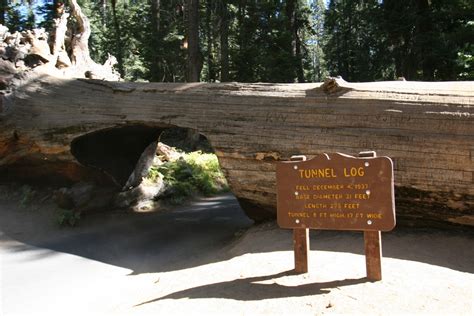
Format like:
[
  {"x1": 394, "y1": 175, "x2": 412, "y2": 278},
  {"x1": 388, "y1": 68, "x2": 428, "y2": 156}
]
[{"x1": 276, "y1": 153, "x2": 395, "y2": 231}]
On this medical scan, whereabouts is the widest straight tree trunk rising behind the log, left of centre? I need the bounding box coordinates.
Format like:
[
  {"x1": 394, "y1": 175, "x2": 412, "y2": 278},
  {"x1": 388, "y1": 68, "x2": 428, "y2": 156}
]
[{"x1": 186, "y1": 0, "x2": 202, "y2": 82}]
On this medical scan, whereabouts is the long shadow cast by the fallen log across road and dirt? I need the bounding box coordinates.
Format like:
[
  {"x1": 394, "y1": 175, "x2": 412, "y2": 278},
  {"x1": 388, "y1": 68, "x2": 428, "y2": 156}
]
[{"x1": 0, "y1": 185, "x2": 474, "y2": 274}]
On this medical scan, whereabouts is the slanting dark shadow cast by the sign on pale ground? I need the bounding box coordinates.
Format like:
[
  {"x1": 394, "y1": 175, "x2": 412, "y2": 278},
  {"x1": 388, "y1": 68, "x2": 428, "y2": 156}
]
[{"x1": 135, "y1": 270, "x2": 369, "y2": 307}]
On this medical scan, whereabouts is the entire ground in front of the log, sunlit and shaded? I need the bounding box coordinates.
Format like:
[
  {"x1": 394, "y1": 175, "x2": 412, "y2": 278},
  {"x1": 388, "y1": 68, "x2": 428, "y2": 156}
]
[{"x1": 0, "y1": 186, "x2": 474, "y2": 316}]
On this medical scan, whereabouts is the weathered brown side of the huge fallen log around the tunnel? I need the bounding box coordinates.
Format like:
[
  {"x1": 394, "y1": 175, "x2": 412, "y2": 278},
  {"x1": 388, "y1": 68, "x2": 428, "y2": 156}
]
[{"x1": 0, "y1": 75, "x2": 474, "y2": 225}]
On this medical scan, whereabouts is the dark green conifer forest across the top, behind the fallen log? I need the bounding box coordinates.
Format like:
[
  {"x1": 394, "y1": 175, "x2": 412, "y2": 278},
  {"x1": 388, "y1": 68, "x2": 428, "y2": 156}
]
[{"x1": 0, "y1": 0, "x2": 474, "y2": 82}]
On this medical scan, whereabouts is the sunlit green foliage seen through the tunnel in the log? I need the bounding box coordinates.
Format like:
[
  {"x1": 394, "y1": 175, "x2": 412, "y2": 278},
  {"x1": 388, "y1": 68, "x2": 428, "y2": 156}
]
[{"x1": 148, "y1": 151, "x2": 228, "y2": 203}]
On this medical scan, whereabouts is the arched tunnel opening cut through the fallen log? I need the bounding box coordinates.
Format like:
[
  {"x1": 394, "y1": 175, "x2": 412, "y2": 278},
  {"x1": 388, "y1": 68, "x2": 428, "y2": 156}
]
[{"x1": 66, "y1": 125, "x2": 228, "y2": 210}]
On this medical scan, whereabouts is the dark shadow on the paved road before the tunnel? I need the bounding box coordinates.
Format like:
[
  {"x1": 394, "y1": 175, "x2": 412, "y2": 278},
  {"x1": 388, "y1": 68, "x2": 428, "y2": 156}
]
[{"x1": 0, "y1": 194, "x2": 253, "y2": 275}]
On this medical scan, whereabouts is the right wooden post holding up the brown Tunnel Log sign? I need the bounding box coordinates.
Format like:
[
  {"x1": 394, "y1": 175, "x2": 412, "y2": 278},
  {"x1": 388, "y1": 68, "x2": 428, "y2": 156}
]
[{"x1": 364, "y1": 231, "x2": 382, "y2": 281}]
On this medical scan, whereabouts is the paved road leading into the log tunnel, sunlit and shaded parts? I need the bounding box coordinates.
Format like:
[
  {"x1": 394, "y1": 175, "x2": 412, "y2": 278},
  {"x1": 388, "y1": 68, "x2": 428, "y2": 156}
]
[{"x1": 0, "y1": 195, "x2": 252, "y2": 315}]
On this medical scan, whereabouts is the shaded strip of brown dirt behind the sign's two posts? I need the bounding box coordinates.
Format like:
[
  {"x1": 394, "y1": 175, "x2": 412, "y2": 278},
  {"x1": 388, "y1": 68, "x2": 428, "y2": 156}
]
[{"x1": 232, "y1": 223, "x2": 474, "y2": 273}]
